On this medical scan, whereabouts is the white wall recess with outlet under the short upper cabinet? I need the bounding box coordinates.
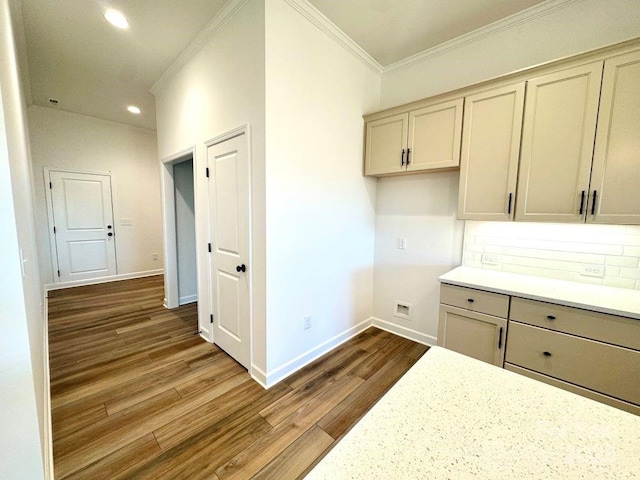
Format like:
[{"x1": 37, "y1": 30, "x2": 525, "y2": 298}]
[{"x1": 373, "y1": 172, "x2": 464, "y2": 345}]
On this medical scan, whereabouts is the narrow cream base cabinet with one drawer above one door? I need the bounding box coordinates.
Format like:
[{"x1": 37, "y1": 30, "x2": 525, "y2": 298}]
[{"x1": 438, "y1": 284, "x2": 509, "y2": 367}]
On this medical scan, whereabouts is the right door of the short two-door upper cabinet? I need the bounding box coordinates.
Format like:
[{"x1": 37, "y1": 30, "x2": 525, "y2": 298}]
[{"x1": 407, "y1": 98, "x2": 464, "y2": 171}]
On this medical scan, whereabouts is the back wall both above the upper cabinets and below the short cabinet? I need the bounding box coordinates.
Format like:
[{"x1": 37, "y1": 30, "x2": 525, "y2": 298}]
[{"x1": 374, "y1": 0, "x2": 640, "y2": 344}]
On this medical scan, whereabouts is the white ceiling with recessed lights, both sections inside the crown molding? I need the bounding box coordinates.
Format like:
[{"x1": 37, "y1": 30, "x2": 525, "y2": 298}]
[{"x1": 21, "y1": 0, "x2": 544, "y2": 129}]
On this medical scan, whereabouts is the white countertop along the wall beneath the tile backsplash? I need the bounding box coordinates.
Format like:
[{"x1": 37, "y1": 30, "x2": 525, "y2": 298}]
[{"x1": 438, "y1": 267, "x2": 640, "y2": 320}]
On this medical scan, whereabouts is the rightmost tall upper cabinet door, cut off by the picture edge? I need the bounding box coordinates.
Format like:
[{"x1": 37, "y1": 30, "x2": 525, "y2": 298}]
[{"x1": 587, "y1": 52, "x2": 640, "y2": 225}]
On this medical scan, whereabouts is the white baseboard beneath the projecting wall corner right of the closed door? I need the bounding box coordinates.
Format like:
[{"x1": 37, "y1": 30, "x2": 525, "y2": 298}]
[{"x1": 251, "y1": 318, "x2": 372, "y2": 388}]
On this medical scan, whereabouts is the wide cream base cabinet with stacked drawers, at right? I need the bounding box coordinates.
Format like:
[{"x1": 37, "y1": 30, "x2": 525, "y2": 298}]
[{"x1": 505, "y1": 297, "x2": 640, "y2": 415}]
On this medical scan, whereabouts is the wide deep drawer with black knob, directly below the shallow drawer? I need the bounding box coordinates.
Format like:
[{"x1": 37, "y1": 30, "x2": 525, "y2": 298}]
[{"x1": 505, "y1": 321, "x2": 640, "y2": 404}]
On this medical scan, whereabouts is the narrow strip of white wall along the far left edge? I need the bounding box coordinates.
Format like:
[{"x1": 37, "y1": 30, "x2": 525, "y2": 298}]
[{"x1": 0, "y1": 0, "x2": 46, "y2": 480}]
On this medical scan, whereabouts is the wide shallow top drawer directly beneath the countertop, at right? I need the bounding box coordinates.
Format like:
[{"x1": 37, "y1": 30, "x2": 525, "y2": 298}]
[{"x1": 509, "y1": 297, "x2": 640, "y2": 350}]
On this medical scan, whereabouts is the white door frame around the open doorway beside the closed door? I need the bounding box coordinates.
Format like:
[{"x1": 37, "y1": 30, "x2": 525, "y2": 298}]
[{"x1": 160, "y1": 145, "x2": 195, "y2": 309}]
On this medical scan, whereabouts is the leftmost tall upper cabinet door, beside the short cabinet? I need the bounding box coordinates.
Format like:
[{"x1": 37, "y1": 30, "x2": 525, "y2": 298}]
[{"x1": 458, "y1": 82, "x2": 525, "y2": 220}]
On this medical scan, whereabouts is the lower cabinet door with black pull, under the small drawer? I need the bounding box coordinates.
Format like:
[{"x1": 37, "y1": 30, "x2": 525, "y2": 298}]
[{"x1": 438, "y1": 304, "x2": 507, "y2": 367}]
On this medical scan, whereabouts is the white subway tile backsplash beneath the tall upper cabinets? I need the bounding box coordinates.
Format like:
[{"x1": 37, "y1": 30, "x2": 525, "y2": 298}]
[{"x1": 462, "y1": 221, "x2": 640, "y2": 290}]
